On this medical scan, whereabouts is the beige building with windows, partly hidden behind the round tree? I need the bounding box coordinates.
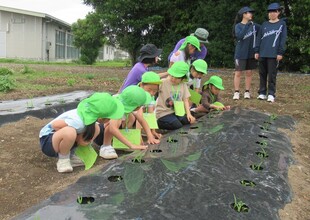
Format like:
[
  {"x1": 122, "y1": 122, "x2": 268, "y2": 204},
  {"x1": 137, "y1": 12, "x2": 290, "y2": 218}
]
[{"x1": 0, "y1": 6, "x2": 128, "y2": 61}]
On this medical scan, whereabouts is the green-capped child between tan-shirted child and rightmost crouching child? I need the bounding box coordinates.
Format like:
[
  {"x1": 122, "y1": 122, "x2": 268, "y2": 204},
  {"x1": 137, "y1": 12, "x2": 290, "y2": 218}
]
[{"x1": 187, "y1": 59, "x2": 208, "y2": 92}]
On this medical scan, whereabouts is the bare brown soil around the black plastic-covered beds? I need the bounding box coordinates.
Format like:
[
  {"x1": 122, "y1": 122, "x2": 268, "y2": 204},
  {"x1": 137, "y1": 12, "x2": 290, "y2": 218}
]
[{"x1": 0, "y1": 64, "x2": 310, "y2": 220}]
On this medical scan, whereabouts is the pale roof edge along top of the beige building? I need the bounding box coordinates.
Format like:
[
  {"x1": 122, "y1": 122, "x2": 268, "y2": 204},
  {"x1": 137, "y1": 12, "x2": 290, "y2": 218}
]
[{"x1": 0, "y1": 5, "x2": 71, "y2": 27}]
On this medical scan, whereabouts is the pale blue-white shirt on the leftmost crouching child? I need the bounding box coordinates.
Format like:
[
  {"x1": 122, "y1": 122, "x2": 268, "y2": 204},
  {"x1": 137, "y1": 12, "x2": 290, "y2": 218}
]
[{"x1": 39, "y1": 109, "x2": 85, "y2": 138}]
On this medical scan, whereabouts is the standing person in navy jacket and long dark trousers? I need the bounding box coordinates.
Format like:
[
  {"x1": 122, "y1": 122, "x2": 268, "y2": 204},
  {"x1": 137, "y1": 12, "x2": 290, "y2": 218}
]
[{"x1": 255, "y1": 3, "x2": 287, "y2": 102}]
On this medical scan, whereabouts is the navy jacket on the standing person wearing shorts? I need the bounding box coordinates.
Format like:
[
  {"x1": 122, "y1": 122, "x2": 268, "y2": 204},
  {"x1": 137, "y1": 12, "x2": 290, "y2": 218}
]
[{"x1": 235, "y1": 22, "x2": 260, "y2": 59}]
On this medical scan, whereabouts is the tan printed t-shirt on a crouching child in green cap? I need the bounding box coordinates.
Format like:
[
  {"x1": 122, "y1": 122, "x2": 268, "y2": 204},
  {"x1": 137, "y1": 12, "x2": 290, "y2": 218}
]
[{"x1": 156, "y1": 77, "x2": 191, "y2": 119}]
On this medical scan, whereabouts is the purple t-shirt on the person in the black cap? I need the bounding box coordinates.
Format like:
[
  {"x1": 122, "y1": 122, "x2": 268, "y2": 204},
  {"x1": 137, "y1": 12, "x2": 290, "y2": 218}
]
[{"x1": 119, "y1": 62, "x2": 148, "y2": 93}]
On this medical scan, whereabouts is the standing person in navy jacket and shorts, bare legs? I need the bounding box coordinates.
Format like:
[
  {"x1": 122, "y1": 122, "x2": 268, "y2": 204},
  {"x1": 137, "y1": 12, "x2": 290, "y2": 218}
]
[{"x1": 233, "y1": 7, "x2": 259, "y2": 100}]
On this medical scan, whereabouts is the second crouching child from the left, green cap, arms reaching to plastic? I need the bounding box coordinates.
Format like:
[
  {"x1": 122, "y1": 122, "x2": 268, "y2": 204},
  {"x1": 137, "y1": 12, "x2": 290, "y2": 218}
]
[{"x1": 99, "y1": 86, "x2": 159, "y2": 159}]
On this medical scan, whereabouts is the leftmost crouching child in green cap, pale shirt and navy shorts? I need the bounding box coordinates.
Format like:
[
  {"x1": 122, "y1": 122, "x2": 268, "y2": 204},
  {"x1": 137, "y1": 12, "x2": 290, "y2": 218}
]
[{"x1": 39, "y1": 93, "x2": 124, "y2": 173}]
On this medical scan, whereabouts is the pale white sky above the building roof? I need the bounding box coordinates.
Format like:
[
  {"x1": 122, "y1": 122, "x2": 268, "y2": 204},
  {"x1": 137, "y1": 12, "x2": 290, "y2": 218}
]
[{"x1": 0, "y1": 0, "x2": 92, "y2": 24}]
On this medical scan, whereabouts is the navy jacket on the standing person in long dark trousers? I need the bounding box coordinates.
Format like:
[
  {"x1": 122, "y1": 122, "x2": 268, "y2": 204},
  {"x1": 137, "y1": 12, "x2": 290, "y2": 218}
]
[{"x1": 255, "y1": 19, "x2": 287, "y2": 58}]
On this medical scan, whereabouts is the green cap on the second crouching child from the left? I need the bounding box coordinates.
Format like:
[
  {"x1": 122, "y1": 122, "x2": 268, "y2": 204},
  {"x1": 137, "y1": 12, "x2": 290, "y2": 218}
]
[{"x1": 116, "y1": 85, "x2": 152, "y2": 113}]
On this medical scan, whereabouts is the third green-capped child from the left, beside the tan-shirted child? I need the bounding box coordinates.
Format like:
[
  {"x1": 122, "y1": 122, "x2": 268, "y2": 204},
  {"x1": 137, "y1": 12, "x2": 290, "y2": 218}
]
[{"x1": 137, "y1": 72, "x2": 162, "y2": 139}]
